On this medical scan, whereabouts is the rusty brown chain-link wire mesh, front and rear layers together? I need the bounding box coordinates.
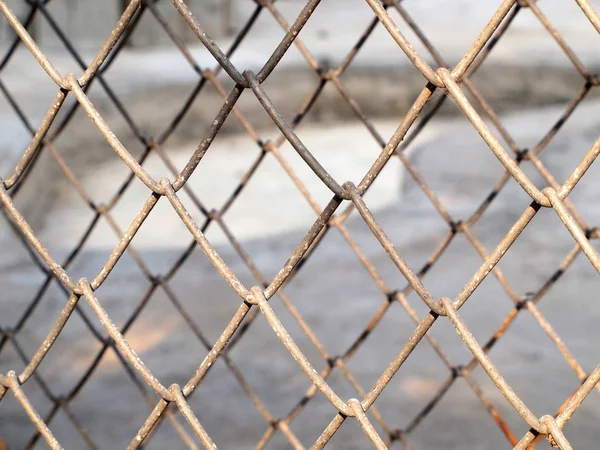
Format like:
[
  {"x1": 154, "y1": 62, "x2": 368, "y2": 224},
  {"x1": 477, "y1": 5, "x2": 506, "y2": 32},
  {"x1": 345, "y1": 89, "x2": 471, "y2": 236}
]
[{"x1": 0, "y1": 0, "x2": 600, "y2": 450}]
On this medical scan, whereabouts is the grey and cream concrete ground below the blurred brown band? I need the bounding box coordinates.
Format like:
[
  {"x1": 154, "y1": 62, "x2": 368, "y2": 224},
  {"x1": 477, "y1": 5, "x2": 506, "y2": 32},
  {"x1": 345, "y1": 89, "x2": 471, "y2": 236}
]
[{"x1": 2, "y1": 103, "x2": 600, "y2": 449}]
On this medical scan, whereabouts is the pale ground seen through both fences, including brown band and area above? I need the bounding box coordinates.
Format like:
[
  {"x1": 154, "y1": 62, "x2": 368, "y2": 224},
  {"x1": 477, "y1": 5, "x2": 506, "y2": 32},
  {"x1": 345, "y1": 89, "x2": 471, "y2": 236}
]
[{"x1": 0, "y1": 0, "x2": 600, "y2": 449}]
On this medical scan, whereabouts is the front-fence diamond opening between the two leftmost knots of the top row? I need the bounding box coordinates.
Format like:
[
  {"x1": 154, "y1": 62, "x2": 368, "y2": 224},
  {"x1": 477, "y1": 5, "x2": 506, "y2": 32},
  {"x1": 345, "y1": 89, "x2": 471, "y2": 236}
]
[{"x1": 99, "y1": 2, "x2": 239, "y2": 150}]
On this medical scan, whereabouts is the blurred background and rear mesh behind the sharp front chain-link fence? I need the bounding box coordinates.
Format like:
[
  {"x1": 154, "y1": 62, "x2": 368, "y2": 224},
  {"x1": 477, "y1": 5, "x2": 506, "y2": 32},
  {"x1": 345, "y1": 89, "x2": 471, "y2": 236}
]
[{"x1": 0, "y1": 0, "x2": 600, "y2": 450}]
